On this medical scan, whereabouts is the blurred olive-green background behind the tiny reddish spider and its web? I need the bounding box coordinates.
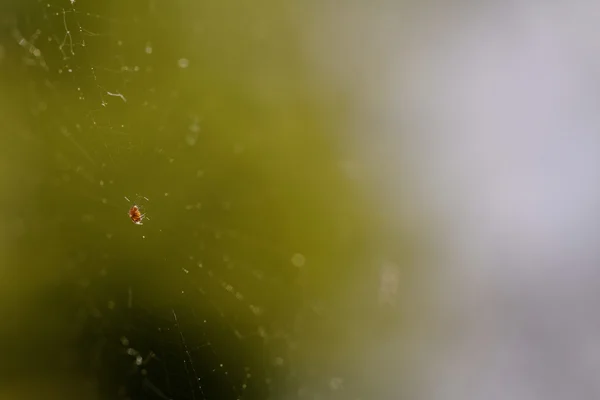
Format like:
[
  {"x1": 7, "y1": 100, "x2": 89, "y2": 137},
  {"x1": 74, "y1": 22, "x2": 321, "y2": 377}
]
[{"x1": 0, "y1": 0, "x2": 415, "y2": 399}]
